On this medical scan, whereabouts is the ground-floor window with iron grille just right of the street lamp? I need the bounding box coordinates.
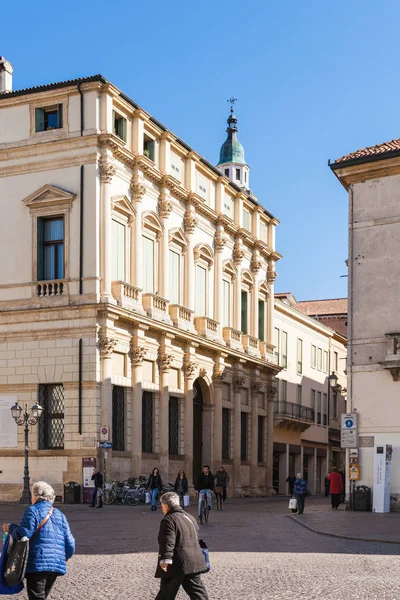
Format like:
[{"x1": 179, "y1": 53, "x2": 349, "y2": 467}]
[{"x1": 39, "y1": 383, "x2": 64, "y2": 450}]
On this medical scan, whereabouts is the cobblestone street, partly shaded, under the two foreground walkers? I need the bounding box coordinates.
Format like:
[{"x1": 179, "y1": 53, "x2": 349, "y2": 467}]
[{"x1": 0, "y1": 499, "x2": 400, "y2": 600}]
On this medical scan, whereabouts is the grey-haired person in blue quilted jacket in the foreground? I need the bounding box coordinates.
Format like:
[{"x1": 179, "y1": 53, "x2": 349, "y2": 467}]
[{"x1": 3, "y1": 481, "x2": 75, "y2": 600}]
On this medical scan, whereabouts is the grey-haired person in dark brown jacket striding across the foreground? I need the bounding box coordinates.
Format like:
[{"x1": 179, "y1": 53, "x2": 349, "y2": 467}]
[{"x1": 155, "y1": 492, "x2": 208, "y2": 600}]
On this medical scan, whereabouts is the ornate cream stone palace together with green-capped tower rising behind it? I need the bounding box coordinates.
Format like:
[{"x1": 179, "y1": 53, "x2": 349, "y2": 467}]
[{"x1": 0, "y1": 59, "x2": 281, "y2": 499}]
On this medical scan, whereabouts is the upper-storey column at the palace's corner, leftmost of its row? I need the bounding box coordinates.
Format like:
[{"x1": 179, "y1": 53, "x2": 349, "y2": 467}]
[{"x1": 99, "y1": 158, "x2": 116, "y2": 302}]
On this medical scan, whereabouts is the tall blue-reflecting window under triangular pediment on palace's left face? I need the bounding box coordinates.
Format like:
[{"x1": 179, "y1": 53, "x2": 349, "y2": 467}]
[{"x1": 37, "y1": 217, "x2": 64, "y2": 281}]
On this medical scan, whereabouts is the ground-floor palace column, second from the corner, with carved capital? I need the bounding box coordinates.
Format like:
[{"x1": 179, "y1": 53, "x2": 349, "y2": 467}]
[{"x1": 129, "y1": 325, "x2": 148, "y2": 475}]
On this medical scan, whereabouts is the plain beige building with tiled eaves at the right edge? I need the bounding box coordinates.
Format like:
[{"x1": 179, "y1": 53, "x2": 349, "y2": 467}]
[{"x1": 330, "y1": 140, "x2": 400, "y2": 510}]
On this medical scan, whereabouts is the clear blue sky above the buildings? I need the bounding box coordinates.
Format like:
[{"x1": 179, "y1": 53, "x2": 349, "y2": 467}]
[{"x1": 0, "y1": 0, "x2": 400, "y2": 300}]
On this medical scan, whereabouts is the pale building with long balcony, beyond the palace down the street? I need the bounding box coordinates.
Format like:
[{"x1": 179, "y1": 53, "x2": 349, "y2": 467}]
[{"x1": 273, "y1": 294, "x2": 347, "y2": 494}]
